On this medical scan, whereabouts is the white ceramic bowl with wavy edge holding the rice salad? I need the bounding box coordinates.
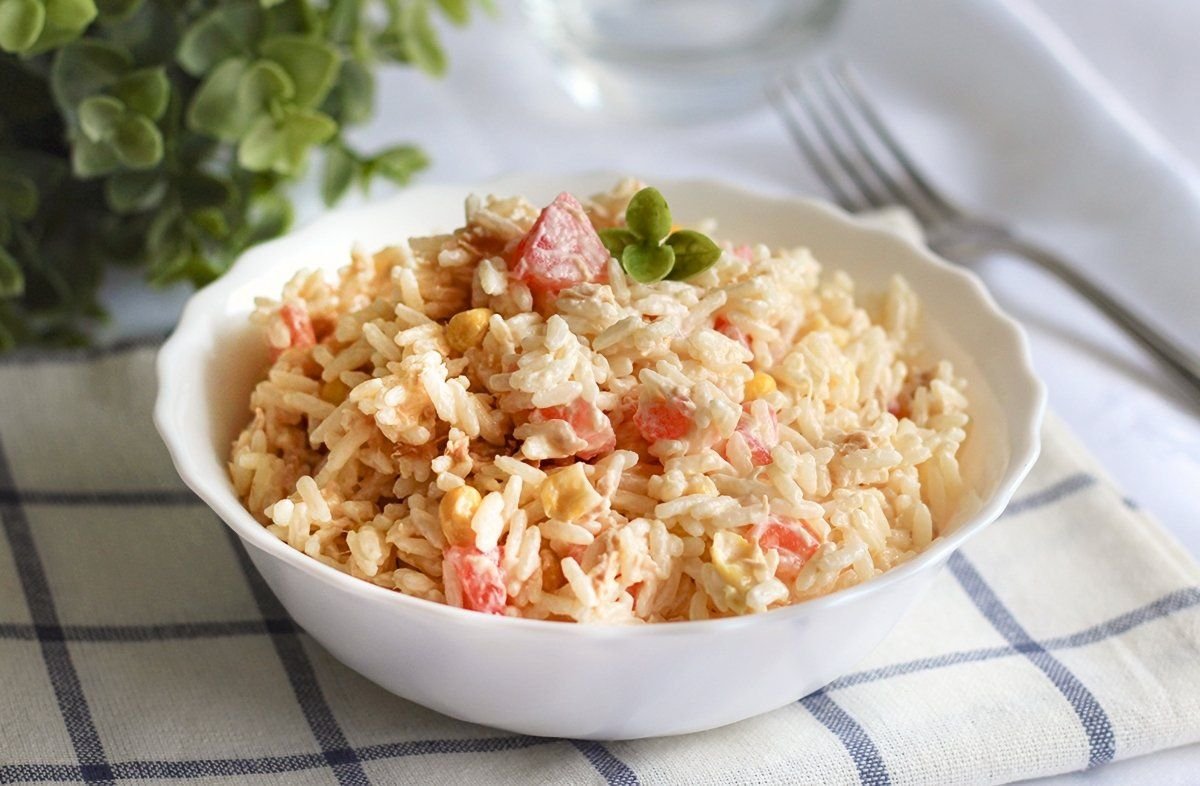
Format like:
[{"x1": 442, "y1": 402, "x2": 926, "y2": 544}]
[{"x1": 155, "y1": 174, "x2": 1045, "y2": 739}]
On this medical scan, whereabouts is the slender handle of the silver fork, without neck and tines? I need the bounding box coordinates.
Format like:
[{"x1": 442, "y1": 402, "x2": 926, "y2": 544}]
[{"x1": 1000, "y1": 236, "x2": 1200, "y2": 404}]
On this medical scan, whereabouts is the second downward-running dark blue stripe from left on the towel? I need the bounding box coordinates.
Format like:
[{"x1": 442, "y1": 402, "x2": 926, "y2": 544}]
[{"x1": 223, "y1": 528, "x2": 371, "y2": 786}]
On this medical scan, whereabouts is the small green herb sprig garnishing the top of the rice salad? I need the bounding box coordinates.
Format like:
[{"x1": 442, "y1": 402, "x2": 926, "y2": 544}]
[{"x1": 600, "y1": 188, "x2": 721, "y2": 284}]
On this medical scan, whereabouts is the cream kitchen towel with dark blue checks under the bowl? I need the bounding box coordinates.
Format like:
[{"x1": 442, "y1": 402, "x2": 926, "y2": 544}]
[{"x1": 0, "y1": 347, "x2": 1200, "y2": 785}]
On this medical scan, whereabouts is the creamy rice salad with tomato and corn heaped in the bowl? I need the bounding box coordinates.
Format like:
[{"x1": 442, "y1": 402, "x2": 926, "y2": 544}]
[{"x1": 229, "y1": 180, "x2": 971, "y2": 623}]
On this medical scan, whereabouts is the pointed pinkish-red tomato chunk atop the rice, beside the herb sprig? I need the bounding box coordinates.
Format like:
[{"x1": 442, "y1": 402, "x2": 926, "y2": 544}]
[{"x1": 512, "y1": 192, "x2": 608, "y2": 293}]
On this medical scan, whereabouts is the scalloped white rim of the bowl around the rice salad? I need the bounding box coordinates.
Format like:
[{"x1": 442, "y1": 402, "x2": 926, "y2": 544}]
[{"x1": 154, "y1": 172, "x2": 1046, "y2": 637}]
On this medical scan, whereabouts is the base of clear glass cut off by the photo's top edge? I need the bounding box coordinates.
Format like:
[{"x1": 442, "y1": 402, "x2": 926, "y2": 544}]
[{"x1": 522, "y1": 0, "x2": 842, "y2": 119}]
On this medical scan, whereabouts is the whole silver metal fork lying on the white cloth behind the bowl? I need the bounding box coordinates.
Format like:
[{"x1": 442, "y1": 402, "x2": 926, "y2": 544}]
[{"x1": 768, "y1": 62, "x2": 1200, "y2": 403}]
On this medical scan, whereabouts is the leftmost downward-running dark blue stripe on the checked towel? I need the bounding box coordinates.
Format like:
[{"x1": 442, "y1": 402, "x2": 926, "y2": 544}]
[{"x1": 0, "y1": 440, "x2": 113, "y2": 784}]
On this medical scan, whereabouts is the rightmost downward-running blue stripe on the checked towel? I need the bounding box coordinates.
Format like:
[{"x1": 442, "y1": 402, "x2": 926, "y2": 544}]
[{"x1": 949, "y1": 552, "x2": 1116, "y2": 768}]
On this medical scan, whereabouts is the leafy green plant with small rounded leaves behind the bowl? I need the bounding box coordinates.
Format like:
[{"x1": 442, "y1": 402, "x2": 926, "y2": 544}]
[{"x1": 0, "y1": 0, "x2": 487, "y2": 349}]
